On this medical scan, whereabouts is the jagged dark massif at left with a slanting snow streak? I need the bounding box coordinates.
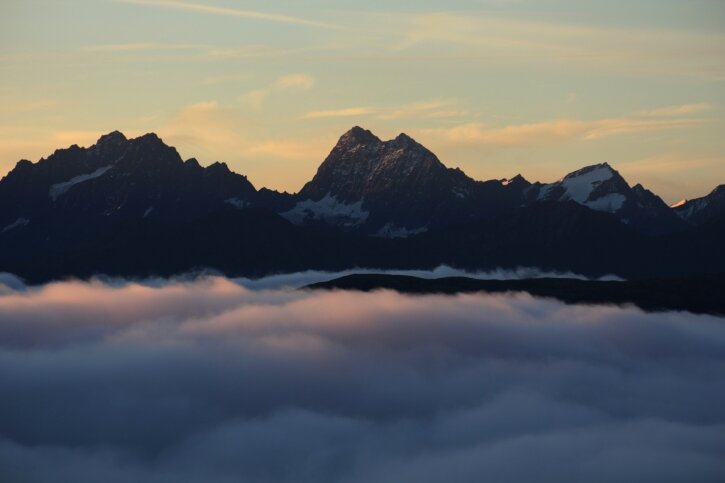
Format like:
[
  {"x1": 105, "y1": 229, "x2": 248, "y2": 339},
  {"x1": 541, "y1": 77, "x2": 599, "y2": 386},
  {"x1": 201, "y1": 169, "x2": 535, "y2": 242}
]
[{"x1": 0, "y1": 132, "x2": 256, "y2": 233}]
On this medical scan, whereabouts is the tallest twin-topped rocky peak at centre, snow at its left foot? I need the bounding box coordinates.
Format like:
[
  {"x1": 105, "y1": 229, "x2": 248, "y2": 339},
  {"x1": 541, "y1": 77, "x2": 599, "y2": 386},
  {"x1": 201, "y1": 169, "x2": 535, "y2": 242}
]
[{"x1": 282, "y1": 127, "x2": 528, "y2": 236}]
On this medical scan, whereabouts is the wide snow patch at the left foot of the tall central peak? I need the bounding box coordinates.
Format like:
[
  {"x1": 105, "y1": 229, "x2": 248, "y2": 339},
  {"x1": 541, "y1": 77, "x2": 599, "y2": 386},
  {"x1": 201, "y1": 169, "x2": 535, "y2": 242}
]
[{"x1": 280, "y1": 193, "x2": 370, "y2": 227}]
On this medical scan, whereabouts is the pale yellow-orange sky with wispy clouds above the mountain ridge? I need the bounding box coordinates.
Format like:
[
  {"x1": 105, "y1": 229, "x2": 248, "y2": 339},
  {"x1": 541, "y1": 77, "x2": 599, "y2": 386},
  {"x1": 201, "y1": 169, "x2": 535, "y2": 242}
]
[{"x1": 0, "y1": 0, "x2": 725, "y2": 203}]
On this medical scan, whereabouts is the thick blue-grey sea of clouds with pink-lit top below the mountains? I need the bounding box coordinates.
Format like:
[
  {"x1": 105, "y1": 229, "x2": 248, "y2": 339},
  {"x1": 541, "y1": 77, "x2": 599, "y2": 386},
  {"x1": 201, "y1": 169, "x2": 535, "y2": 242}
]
[{"x1": 0, "y1": 277, "x2": 725, "y2": 483}]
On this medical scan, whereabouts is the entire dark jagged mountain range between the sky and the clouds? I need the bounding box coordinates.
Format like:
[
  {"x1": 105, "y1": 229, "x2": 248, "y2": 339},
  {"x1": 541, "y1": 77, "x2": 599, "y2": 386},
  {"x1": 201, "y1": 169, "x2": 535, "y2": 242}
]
[{"x1": 0, "y1": 127, "x2": 725, "y2": 281}]
